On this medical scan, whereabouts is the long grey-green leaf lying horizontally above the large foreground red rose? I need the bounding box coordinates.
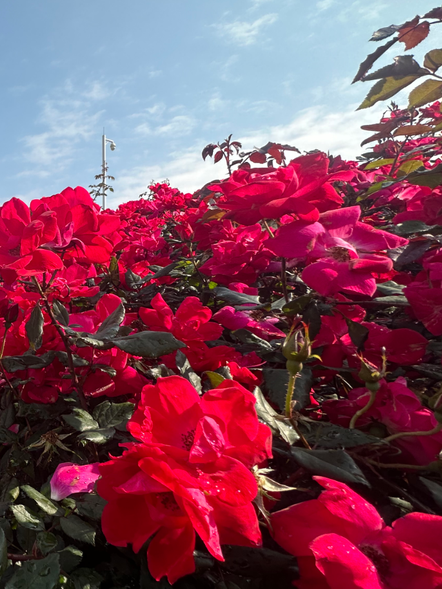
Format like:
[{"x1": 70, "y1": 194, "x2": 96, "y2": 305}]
[{"x1": 112, "y1": 331, "x2": 186, "y2": 358}]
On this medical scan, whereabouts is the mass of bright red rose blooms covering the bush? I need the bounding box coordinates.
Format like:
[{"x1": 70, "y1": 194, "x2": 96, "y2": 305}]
[{"x1": 4, "y1": 104, "x2": 442, "y2": 589}]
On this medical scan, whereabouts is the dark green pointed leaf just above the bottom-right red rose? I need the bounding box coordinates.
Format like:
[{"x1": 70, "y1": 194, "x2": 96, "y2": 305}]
[{"x1": 290, "y1": 446, "x2": 370, "y2": 486}]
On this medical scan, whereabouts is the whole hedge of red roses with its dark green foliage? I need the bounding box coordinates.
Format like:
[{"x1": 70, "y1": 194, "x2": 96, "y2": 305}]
[{"x1": 0, "y1": 103, "x2": 442, "y2": 589}]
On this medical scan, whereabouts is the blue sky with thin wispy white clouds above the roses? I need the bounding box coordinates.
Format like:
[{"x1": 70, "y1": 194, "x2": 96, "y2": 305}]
[{"x1": 0, "y1": 0, "x2": 442, "y2": 206}]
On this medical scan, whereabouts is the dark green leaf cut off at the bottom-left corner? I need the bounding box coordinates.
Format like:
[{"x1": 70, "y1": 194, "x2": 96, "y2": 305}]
[{"x1": 5, "y1": 554, "x2": 60, "y2": 589}]
